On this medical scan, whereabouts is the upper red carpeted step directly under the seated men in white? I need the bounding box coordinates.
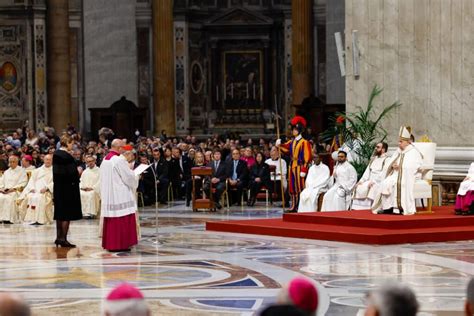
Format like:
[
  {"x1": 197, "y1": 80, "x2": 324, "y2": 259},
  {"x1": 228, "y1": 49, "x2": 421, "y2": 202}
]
[{"x1": 283, "y1": 206, "x2": 474, "y2": 229}]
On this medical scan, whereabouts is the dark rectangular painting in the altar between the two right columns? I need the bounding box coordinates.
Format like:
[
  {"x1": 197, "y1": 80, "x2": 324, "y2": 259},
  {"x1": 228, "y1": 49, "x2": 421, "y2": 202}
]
[{"x1": 223, "y1": 51, "x2": 263, "y2": 107}]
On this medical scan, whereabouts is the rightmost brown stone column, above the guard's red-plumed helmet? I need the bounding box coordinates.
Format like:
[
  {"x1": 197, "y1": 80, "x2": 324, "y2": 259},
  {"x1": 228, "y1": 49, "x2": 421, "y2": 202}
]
[{"x1": 291, "y1": 0, "x2": 314, "y2": 106}]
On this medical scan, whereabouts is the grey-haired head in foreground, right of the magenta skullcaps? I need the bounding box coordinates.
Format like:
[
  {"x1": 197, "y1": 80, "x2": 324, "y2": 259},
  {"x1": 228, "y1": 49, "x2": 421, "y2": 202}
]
[{"x1": 369, "y1": 282, "x2": 419, "y2": 316}]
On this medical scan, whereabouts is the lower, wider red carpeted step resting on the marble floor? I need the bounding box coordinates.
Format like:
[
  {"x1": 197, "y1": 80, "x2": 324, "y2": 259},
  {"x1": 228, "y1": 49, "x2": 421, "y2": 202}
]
[{"x1": 206, "y1": 219, "x2": 474, "y2": 245}]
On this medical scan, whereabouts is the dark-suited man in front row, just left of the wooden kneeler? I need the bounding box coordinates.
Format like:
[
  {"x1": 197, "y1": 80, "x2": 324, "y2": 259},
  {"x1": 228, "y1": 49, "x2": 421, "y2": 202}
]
[{"x1": 170, "y1": 147, "x2": 191, "y2": 199}]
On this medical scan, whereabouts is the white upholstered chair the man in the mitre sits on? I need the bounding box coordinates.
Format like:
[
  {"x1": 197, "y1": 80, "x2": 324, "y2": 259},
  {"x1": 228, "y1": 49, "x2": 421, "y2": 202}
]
[{"x1": 413, "y1": 142, "x2": 436, "y2": 213}]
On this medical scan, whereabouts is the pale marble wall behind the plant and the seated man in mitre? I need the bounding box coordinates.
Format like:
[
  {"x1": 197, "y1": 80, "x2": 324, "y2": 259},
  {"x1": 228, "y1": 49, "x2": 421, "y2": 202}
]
[{"x1": 345, "y1": 0, "x2": 474, "y2": 148}]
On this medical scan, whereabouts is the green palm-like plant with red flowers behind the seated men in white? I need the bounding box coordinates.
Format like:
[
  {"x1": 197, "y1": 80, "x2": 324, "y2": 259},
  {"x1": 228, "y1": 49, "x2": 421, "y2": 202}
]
[{"x1": 321, "y1": 85, "x2": 401, "y2": 178}]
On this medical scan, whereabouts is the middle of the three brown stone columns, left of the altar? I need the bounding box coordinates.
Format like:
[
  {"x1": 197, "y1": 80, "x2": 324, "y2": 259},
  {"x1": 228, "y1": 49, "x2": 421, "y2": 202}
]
[{"x1": 152, "y1": 0, "x2": 176, "y2": 135}]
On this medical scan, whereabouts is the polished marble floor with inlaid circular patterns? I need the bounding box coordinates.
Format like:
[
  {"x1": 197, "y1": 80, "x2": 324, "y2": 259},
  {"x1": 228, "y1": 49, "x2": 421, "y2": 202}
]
[{"x1": 0, "y1": 202, "x2": 474, "y2": 316}]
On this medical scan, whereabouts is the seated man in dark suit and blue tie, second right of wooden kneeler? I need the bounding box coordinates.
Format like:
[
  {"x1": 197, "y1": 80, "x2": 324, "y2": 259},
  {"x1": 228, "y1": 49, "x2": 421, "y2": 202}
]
[{"x1": 227, "y1": 149, "x2": 249, "y2": 204}]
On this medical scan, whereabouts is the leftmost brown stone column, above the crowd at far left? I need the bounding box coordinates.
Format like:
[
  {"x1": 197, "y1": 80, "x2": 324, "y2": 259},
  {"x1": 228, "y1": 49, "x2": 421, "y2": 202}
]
[{"x1": 46, "y1": 0, "x2": 71, "y2": 133}]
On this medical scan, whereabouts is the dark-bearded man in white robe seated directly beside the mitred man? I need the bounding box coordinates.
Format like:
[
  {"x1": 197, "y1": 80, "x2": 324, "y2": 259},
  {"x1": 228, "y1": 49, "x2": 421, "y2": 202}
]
[{"x1": 352, "y1": 142, "x2": 388, "y2": 210}]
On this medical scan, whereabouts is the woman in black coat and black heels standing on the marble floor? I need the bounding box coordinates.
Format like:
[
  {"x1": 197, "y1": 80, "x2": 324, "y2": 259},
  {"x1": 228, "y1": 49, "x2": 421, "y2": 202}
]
[{"x1": 53, "y1": 135, "x2": 82, "y2": 247}]
